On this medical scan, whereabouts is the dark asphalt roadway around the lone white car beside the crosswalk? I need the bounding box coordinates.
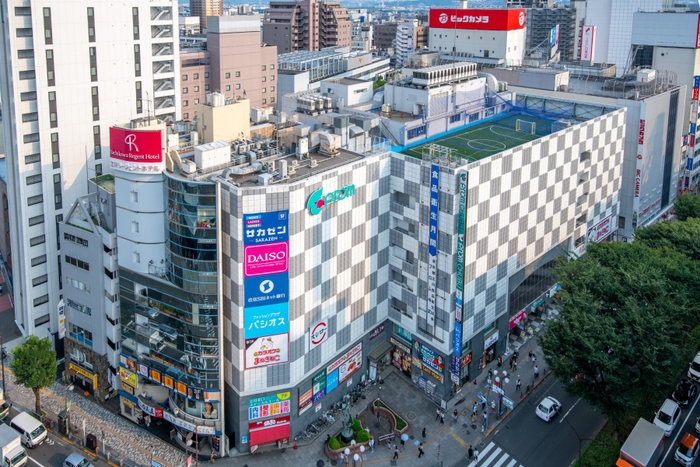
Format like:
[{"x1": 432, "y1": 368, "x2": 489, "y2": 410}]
[{"x1": 479, "y1": 377, "x2": 603, "y2": 467}]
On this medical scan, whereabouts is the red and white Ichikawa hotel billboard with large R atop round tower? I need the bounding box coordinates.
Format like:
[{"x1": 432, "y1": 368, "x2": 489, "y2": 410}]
[{"x1": 109, "y1": 127, "x2": 163, "y2": 173}]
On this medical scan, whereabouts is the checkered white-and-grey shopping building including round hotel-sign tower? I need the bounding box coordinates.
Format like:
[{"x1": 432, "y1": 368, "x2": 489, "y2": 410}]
[{"x1": 111, "y1": 93, "x2": 625, "y2": 451}]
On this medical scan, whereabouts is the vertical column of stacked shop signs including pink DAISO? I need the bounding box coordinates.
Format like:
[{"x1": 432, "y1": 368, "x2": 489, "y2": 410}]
[{"x1": 243, "y1": 210, "x2": 289, "y2": 370}]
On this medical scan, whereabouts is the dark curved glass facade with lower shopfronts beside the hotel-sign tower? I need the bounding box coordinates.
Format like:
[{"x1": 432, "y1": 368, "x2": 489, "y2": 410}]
[{"x1": 120, "y1": 176, "x2": 221, "y2": 442}]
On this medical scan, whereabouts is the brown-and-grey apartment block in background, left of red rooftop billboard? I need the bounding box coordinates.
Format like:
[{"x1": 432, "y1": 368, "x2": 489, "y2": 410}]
[{"x1": 263, "y1": 0, "x2": 352, "y2": 54}]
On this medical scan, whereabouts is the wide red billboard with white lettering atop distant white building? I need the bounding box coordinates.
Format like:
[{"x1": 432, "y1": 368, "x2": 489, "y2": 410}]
[{"x1": 429, "y1": 8, "x2": 525, "y2": 31}]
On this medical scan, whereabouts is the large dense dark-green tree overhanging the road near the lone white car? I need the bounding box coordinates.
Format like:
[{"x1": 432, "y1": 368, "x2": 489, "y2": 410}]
[{"x1": 539, "y1": 242, "x2": 696, "y2": 431}]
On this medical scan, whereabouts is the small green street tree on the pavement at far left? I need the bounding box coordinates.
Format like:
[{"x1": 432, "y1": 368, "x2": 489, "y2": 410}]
[{"x1": 10, "y1": 336, "x2": 58, "y2": 414}]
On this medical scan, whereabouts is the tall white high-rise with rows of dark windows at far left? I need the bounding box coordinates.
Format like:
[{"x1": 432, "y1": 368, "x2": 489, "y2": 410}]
[{"x1": 0, "y1": 0, "x2": 180, "y2": 342}]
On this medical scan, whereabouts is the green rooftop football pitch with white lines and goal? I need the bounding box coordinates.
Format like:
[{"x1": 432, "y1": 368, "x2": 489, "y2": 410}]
[{"x1": 403, "y1": 115, "x2": 554, "y2": 161}]
